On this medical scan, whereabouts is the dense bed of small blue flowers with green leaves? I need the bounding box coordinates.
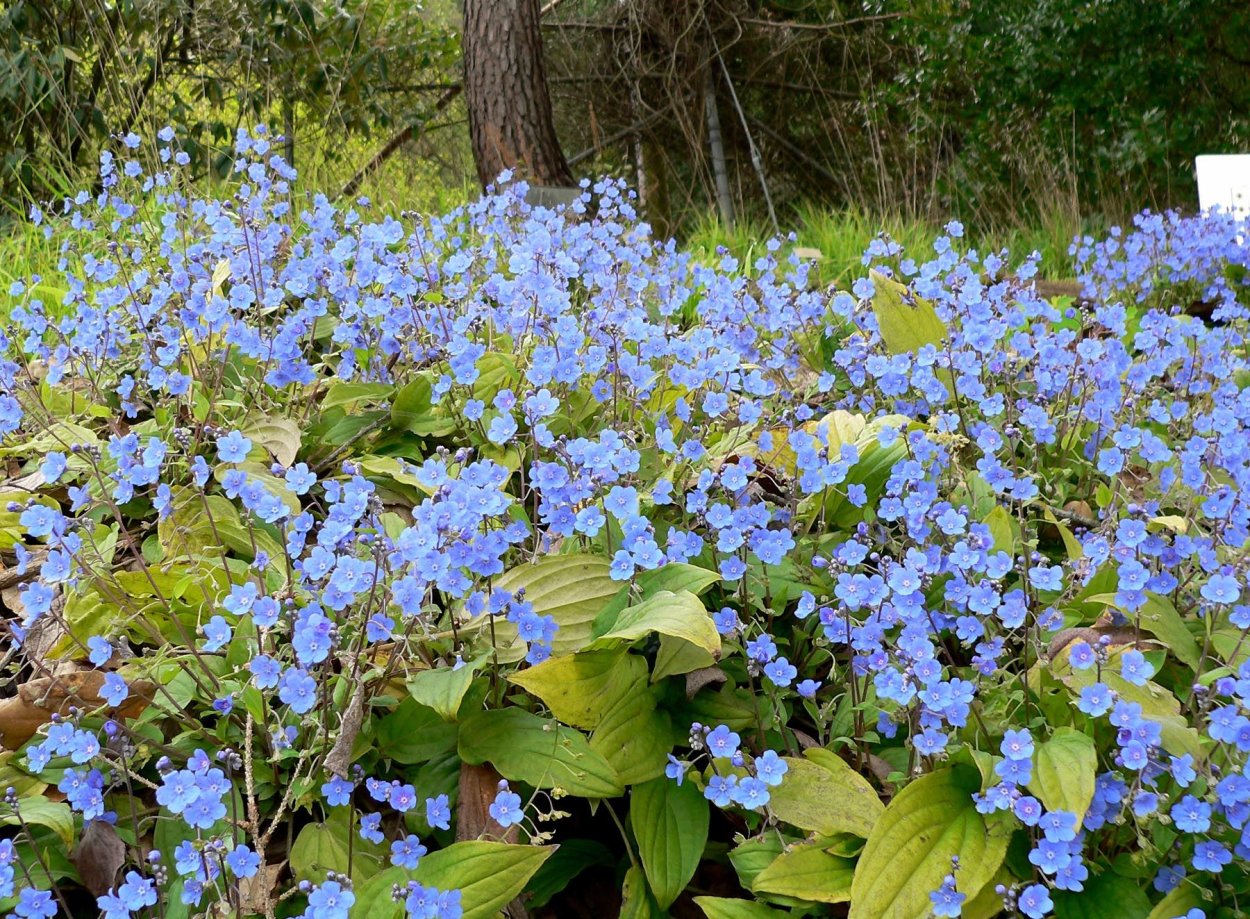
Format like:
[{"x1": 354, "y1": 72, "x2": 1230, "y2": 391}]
[{"x1": 0, "y1": 130, "x2": 1250, "y2": 919}]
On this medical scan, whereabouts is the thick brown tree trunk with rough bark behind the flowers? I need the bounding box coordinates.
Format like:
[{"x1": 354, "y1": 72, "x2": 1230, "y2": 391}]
[{"x1": 461, "y1": 0, "x2": 573, "y2": 188}]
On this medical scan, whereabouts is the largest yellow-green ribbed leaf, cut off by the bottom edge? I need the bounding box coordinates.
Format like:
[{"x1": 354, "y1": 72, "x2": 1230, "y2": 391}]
[{"x1": 850, "y1": 766, "x2": 1009, "y2": 919}]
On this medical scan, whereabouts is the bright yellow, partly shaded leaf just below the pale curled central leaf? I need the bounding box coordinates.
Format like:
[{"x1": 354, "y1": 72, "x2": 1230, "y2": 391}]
[{"x1": 508, "y1": 649, "x2": 646, "y2": 730}]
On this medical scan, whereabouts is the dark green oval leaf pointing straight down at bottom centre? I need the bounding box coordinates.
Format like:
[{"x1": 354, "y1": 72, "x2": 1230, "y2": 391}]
[{"x1": 629, "y1": 776, "x2": 709, "y2": 909}]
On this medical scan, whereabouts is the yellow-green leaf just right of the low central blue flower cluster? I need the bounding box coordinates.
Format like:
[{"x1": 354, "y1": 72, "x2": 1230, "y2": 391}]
[{"x1": 769, "y1": 749, "x2": 885, "y2": 838}]
